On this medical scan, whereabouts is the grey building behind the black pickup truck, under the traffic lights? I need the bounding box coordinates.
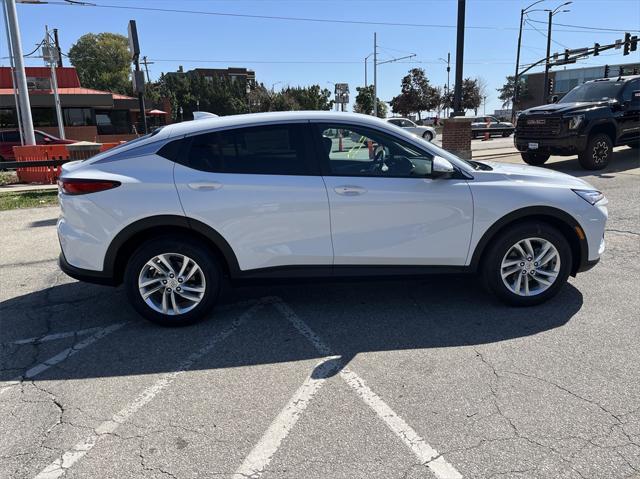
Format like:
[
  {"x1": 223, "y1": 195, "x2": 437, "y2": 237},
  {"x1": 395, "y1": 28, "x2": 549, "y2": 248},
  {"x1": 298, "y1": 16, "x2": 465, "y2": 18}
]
[{"x1": 517, "y1": 63, "x2": 640, "y2": 110}]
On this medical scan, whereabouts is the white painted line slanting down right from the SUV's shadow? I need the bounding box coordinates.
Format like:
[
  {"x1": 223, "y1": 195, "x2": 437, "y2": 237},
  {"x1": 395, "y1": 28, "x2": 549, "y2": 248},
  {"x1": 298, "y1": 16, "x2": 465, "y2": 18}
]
[{"x1": 273, "y1": 299, "x2": 462, "y2": 479}]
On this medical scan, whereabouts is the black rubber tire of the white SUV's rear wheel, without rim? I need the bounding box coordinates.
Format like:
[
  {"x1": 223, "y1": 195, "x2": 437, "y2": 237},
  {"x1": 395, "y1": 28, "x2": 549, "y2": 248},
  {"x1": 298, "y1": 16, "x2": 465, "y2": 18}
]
[{"x1": 124, "y1": 236, "x2": 222, "y2": 326}]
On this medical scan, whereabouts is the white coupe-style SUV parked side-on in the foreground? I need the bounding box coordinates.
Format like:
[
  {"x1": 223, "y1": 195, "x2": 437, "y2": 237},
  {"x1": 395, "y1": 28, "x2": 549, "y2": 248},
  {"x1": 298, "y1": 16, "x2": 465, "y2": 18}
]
[{"x1": 58, "y1": 112, "x2": 607, "y2": 325}]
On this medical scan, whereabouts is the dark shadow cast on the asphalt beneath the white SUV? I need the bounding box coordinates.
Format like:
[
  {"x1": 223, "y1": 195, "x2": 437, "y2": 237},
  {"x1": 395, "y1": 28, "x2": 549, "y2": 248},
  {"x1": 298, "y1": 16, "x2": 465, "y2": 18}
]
[{"x1": 0, "y1": 276, "x2": 583, "y2": 381}]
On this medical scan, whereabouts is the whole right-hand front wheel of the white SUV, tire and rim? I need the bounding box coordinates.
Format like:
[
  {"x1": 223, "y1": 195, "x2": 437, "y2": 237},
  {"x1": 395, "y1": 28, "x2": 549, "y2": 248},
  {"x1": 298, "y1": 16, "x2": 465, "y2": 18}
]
[{"x1": 482, "y1": 221, "x2": 572, "y2": 306}]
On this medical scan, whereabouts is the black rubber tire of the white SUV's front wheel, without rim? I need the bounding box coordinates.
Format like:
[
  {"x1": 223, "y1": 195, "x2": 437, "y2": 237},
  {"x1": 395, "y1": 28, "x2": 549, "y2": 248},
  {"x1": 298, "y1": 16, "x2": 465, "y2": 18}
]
[{"x1": 482, "y1": 221, "x2": 572, "y2": 306}]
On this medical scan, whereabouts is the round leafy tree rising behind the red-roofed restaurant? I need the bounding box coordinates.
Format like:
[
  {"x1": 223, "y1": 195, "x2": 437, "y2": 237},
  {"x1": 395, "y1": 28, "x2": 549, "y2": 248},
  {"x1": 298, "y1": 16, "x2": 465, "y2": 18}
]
[{"x1": 69, "y1": 32, "x2": 131, "y2": 94}]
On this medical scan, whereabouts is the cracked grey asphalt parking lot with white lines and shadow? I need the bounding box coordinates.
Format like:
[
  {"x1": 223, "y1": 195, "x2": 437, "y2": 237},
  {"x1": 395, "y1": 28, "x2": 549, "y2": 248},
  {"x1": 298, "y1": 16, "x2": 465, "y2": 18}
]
[{"x1": 0, "y1": 148, "x2": 640, "y2": 479}]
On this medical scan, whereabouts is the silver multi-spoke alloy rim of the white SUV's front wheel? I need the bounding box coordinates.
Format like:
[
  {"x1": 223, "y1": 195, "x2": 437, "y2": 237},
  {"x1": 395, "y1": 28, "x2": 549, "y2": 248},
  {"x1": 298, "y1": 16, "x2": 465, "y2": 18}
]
[{"x1": 500, "y1": 238, "x2": 560, "y2": 296}]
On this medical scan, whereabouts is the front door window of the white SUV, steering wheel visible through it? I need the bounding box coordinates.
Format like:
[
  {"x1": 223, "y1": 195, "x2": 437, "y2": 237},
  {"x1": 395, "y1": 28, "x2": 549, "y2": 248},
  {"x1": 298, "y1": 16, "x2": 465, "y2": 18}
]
[{"x1": 317, "y1": 124, "x2": 433, "y2": 178}]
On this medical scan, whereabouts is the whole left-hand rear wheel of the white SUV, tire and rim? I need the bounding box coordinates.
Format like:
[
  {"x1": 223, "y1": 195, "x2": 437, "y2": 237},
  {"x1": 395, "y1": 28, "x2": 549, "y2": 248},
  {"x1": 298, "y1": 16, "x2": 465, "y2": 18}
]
[{"x1": 124, "y1": 236, "x2": 222, "y2": 326}]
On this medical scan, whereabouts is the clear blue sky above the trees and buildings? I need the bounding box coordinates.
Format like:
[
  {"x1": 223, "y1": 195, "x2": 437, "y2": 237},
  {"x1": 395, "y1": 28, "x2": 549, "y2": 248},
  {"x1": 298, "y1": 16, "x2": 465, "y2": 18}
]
[{"x1": 0, "y1": 0, "x2": 640, "y2": 112}]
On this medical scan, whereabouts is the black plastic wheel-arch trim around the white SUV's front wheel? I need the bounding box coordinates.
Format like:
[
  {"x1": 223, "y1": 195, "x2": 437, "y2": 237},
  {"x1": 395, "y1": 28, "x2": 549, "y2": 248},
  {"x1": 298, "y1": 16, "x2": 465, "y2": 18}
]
[{"x1": 470, "y1": 206, "x2": 589, "y2": 274}]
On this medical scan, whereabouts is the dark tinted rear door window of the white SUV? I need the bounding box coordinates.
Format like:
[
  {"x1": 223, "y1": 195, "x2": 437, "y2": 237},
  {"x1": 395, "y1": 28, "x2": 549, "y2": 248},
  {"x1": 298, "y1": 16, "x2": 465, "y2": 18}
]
[{"x1": 184, "y1": 124, "x2": 314, "y2": 175}]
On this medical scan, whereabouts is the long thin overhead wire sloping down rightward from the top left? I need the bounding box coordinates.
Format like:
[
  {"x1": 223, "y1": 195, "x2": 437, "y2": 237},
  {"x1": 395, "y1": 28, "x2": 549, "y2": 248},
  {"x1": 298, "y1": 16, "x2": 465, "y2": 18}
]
[{"x1": 17, "y1": 0, "x2": 636, "y2": 33}]
